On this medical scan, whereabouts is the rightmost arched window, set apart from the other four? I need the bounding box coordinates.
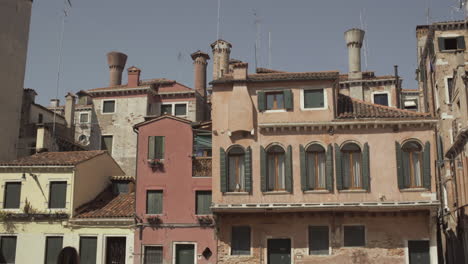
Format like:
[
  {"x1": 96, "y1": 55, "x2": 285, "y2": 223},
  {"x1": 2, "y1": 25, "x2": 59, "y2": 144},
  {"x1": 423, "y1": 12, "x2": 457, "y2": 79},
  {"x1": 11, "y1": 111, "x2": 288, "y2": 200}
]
[{"x1": 401, "y1": 141, "x2": 423, "y2": 188}]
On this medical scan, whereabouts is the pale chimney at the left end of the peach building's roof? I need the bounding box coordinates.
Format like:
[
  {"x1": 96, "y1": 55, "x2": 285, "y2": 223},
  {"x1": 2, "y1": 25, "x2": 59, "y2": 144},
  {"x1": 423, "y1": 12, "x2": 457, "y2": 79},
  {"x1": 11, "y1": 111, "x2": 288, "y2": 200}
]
[{"x1": 211, "y1": 39, "x2": 232, "y2": 80}]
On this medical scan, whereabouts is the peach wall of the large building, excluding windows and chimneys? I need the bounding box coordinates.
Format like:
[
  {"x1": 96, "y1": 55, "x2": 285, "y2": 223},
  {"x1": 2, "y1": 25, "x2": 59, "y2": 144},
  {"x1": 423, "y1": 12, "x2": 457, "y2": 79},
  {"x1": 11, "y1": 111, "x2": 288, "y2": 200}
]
[{"x1": 212, "y1": 63, "x2": 439, "y2": 264}]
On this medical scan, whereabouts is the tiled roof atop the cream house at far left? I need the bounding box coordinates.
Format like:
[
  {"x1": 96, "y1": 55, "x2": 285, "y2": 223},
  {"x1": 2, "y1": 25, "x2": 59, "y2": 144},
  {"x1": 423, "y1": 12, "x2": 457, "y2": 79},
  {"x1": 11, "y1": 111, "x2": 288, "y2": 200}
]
[{"x1": 0, "y1": 150, "x2": 107, "y2": 166}]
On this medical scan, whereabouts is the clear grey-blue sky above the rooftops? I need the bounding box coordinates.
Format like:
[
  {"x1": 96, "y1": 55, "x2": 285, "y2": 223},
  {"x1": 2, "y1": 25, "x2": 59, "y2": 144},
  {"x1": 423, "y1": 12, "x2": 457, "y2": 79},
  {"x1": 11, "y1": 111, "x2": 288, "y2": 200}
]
[{"x1": 24, "y1": 0, "x2": 464, "y2": 105}]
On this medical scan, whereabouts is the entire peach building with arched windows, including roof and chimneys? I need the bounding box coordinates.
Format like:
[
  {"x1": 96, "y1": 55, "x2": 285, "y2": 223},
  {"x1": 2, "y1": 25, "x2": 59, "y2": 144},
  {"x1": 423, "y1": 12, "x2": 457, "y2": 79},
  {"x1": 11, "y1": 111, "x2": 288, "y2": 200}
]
[{"x1": 211, "y1": 29, "x2": 439, "y2": 263}]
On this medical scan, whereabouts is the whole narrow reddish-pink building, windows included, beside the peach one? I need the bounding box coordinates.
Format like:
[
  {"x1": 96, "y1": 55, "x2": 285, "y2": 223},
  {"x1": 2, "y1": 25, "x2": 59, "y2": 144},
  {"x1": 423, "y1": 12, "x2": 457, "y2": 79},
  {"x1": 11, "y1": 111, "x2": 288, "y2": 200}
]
[{"x1": 134, "y1": 115, "x2": 216, "y2": 264}]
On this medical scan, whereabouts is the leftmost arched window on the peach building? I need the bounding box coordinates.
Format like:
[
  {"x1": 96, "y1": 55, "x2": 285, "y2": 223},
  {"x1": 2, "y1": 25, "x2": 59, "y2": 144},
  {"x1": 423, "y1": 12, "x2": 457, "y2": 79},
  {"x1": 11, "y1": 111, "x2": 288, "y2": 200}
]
[{"x1": 228, "y1": 146, "x2": 245, "y2": 192}]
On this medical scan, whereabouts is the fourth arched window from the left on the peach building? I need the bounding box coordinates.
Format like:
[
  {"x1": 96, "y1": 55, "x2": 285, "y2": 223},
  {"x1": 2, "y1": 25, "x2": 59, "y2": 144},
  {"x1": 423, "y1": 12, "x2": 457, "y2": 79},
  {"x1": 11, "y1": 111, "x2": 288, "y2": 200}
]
[{"x1": 341, "y1": 143, "x2": 363, "y2": 189}]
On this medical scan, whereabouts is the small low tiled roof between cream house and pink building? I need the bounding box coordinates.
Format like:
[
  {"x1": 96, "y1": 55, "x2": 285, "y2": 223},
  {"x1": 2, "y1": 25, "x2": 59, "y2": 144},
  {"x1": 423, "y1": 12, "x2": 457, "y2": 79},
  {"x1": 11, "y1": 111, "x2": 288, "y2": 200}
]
[{"x1": 75, "y1": 186, "x2": 135, "y2": 218}]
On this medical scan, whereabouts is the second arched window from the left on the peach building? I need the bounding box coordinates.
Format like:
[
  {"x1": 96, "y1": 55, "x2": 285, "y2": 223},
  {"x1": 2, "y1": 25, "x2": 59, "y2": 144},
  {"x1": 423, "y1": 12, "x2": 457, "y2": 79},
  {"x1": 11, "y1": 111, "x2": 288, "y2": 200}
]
[{"x1": 267, "y1": 145, "x2": 286, "y2": 191}]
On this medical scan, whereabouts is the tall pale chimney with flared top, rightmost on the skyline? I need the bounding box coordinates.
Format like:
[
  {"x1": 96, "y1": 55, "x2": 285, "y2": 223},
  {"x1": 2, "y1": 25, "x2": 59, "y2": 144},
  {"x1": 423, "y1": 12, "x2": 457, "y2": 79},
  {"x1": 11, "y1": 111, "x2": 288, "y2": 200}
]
[{"x1": 345, "y1": 28, "x2": 364, "y2": 79}]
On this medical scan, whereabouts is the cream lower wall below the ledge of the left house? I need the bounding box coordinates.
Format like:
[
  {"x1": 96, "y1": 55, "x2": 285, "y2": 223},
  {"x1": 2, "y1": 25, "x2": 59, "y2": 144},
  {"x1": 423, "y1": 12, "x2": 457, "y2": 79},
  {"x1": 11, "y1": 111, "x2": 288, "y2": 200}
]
[{"x1": 0, "y1": 222, "x2": 134, "y2": 264}]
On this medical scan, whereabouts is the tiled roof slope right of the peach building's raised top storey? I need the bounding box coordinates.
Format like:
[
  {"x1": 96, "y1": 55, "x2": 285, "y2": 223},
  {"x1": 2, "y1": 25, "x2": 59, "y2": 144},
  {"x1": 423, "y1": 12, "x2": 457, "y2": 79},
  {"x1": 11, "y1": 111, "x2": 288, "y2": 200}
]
[{"x1": 337, "y1": 94, "x2": 430, "y2": 119}]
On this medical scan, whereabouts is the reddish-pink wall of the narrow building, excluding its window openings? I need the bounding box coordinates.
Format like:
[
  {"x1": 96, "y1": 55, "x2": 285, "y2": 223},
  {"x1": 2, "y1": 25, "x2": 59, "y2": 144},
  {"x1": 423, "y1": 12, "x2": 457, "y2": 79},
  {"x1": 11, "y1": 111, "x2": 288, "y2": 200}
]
[{"x1": 135, "y1": 115, "x2": 216, "y2": 264}]
